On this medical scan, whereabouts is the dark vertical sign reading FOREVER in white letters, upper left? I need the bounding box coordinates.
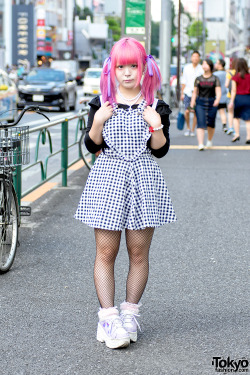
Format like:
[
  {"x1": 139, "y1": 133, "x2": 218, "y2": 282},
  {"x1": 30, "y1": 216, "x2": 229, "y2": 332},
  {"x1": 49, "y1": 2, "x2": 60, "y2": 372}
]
[{"x1": 12, "y1": 4, "x2": 34, "y2": 65}]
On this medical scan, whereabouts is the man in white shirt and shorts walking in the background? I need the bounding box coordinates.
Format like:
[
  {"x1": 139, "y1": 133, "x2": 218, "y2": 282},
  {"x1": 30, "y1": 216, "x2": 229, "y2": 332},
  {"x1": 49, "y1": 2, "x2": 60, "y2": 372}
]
[{"x1": 181, "y1": 51, "x2": 203, "y2": 136}]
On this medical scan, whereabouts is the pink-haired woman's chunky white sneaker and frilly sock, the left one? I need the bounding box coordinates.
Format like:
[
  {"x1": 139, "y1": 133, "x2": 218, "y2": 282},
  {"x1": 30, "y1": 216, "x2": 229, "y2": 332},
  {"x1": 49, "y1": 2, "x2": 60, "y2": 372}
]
[{"x1": 96, "y1": 307, "x2": 130, "y2": 349}]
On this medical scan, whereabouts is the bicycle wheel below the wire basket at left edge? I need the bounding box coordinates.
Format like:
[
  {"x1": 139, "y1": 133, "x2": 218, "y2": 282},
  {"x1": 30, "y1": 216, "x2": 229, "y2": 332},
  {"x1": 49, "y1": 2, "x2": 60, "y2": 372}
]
[{"x1": 0, "y1": 177, "x2": 18, "y2": 274}]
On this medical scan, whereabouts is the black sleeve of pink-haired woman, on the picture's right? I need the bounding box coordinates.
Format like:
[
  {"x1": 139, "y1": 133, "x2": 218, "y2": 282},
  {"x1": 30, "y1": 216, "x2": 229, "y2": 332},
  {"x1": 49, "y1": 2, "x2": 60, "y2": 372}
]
[{"x1": 147, "y1": 100, "x2": 172, "y2": 158}]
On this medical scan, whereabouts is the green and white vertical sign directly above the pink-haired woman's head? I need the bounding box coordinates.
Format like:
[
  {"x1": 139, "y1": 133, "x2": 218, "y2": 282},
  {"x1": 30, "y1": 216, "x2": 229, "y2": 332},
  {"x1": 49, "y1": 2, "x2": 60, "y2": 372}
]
[{"x1": 122, "y1": 0, "x2": 151, "y2": 53}]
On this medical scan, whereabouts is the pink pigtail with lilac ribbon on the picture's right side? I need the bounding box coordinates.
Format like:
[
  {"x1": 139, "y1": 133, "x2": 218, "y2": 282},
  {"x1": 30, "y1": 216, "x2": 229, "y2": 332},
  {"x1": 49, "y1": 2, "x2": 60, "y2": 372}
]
[{"x1": 142, "y1": 55, "x2": 162, "y2": 105}]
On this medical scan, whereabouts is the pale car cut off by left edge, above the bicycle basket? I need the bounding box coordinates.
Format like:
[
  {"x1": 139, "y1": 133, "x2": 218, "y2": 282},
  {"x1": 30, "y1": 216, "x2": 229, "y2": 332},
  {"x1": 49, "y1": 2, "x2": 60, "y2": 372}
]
[{"x1": 0, "y1": 69, "x2": 18, "y2": 122}]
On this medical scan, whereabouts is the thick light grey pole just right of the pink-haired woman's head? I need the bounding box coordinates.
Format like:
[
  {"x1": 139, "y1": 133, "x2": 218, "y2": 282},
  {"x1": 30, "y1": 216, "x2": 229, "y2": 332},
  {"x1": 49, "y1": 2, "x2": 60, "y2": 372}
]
[{"x1": 160, "y1": 0, "x2": 172, "y2": 103}]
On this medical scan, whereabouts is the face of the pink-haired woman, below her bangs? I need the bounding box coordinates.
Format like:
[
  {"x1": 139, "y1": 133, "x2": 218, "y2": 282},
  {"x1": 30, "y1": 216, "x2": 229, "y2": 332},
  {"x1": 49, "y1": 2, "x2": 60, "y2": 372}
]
[{"x1": 115, "y1": 63, "x2": 141, "y2": 89}]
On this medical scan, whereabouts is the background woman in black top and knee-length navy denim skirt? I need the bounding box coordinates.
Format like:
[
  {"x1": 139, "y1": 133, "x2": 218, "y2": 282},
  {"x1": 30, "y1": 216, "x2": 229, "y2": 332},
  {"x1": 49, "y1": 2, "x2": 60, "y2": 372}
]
[{"x1": 190, "y1": 59, "x2": 221, "y2": 151}]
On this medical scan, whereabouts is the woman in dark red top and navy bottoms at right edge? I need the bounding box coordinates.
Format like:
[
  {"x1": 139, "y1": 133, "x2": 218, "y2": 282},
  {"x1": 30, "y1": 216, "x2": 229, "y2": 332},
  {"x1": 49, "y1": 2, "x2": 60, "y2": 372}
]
[{"x1": 229, "y1": 58, "x2": 250, "y2": 144}]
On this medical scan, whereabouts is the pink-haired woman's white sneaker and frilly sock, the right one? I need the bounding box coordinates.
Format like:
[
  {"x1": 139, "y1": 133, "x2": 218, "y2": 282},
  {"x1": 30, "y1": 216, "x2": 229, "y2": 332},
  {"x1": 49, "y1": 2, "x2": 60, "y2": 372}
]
[{"x1": 120, "y1": 301, "x2": 141, "y2": 342}]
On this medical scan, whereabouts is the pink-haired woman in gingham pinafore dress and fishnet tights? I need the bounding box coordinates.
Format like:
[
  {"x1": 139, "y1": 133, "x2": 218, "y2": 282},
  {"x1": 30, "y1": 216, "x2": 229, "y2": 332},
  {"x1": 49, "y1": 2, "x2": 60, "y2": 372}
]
[{"x1": 75, "y1": 38, "x2": 176, "y2": 348}]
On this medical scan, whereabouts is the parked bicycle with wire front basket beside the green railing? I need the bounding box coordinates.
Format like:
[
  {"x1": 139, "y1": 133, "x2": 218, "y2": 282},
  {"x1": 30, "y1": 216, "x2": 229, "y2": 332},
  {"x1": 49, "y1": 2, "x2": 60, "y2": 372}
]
[{"x1": 0, "y1": 105, "x2": 50, "y2": 274}]
